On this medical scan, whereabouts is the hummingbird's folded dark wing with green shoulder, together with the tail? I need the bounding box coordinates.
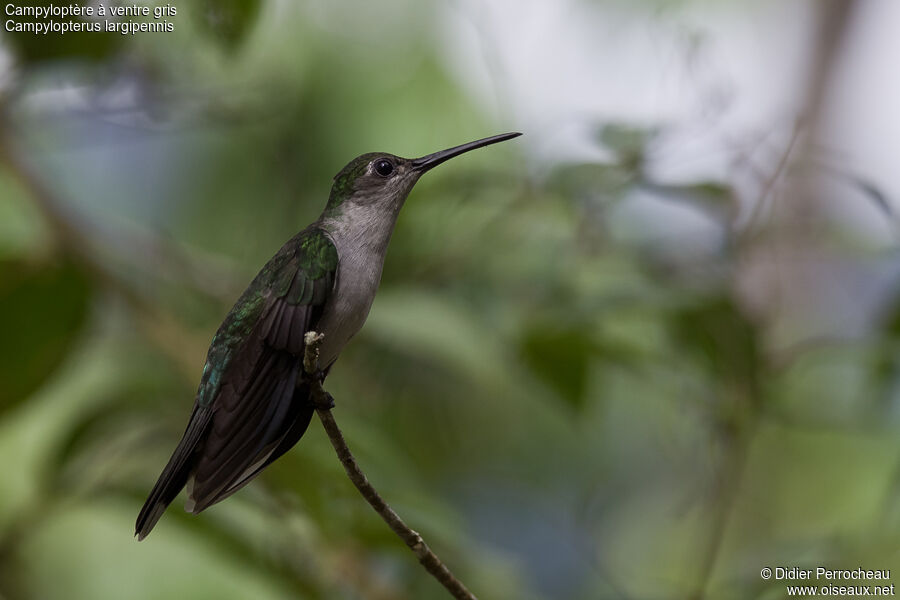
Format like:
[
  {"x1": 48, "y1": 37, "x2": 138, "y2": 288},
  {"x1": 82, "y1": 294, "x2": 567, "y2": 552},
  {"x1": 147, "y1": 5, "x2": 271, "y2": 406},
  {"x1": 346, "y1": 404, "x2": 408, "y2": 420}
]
[{"x1": 136, "y1": 228, "x2": 338, "y2": 538}]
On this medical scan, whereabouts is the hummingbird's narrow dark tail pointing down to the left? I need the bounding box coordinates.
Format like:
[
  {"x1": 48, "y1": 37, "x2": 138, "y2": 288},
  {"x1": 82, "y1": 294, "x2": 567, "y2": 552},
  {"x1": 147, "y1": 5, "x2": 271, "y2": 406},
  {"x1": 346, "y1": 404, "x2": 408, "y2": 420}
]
[{"x1": 134, "y1": 406, "x2": 212, "y2": 541}]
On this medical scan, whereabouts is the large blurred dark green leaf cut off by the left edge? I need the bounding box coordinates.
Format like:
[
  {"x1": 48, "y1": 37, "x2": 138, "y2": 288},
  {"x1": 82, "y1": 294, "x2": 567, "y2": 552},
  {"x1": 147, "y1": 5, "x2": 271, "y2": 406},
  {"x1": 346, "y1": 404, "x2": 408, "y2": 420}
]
[{"x1": 0, "y1": 260, "x2": 91, "y2": 414}]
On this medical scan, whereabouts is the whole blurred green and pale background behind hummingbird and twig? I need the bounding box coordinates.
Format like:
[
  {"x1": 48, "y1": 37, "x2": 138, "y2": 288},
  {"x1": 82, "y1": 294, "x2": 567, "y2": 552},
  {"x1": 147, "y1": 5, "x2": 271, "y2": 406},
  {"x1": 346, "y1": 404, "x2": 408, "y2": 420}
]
[{"x1": 0, "y1": 0, "x2": 900, "y2": 600}]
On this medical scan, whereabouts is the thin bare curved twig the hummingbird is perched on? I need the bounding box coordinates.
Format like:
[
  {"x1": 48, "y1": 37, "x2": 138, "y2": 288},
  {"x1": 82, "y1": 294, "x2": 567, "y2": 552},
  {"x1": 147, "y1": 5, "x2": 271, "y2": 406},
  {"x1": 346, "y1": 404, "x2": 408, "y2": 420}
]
[{"x1": 303, "y1": 331, "x2": 477, "y2": 600}]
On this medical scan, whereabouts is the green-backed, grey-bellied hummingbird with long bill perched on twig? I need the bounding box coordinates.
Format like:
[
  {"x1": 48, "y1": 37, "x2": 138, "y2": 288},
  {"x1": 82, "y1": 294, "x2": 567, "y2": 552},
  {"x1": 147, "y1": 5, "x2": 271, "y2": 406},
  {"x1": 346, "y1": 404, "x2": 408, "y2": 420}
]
[{"x1": 135, "y1": 132, "x2": 521, "y2": 540}]
